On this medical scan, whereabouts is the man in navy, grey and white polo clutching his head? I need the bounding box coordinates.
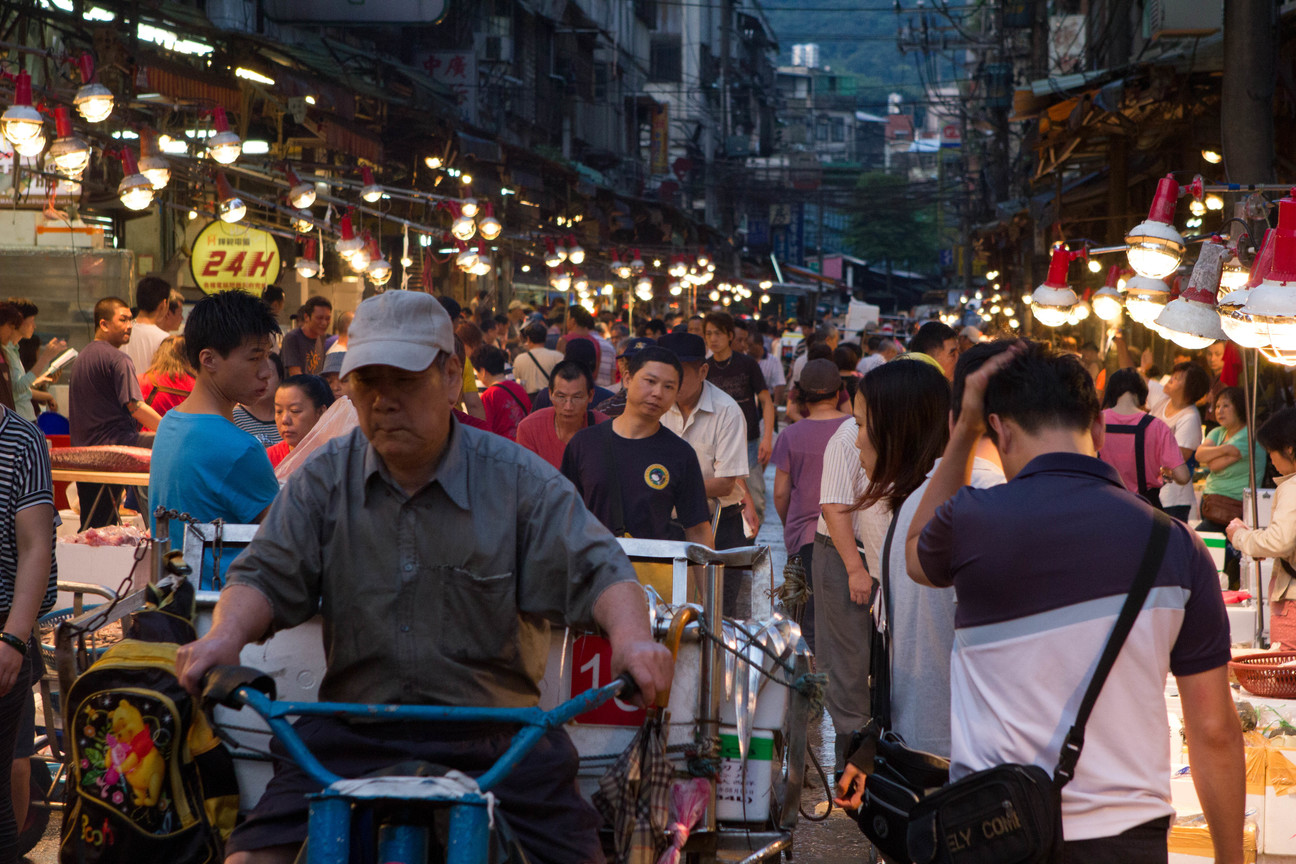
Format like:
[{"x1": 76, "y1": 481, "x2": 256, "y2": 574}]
[{"x1": 906, "y1": 342, "x2": 1245, "y2": 864}]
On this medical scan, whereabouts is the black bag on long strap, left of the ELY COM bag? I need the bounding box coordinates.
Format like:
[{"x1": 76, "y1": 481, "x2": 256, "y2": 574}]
[{"x1": 850, "y1": 510, "x2": 950, "y2": 861}]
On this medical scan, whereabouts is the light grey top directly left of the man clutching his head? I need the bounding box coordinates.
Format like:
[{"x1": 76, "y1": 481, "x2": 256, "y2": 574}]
[{"x1": 876, "y1": 459, "x2": 1004, "y2": 756}]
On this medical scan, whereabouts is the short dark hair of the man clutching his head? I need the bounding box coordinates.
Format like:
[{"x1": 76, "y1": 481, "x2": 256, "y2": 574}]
[{"x1": 984, "y1": 341, "x2": 1099, "y2": 443}]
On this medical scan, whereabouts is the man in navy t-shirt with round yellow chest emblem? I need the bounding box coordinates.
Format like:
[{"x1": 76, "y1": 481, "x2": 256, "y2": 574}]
[{"x1": 562, "y1": 346, "x2": 715, "y2": 547}]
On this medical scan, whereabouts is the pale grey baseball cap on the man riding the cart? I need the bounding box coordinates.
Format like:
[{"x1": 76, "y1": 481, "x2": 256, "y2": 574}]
[{"x1": 340, "y1": 290, "x2": 455, "y2": 378}]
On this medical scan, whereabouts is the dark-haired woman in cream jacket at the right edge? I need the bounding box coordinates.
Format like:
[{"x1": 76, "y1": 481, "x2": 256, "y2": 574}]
[{"x1": 1225, "y1": 408, "x2": 1296, "y2": 650}]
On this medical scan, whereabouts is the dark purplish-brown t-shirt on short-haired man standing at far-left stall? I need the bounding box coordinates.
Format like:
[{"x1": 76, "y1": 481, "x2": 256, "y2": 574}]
[{"x1": 67, "y1": 339, "x2": 144, "y2": 447}]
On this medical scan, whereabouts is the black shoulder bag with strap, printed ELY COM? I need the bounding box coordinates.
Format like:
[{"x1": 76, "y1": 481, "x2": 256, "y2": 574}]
[{"x1": 908, "y1": 510, "x2": 1170, "y2": 864}]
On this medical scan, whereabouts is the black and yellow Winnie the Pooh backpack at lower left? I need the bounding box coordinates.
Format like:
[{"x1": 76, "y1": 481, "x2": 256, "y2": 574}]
[{"x1": 60, "y1": 583, "x2": 238, "y2": 864}]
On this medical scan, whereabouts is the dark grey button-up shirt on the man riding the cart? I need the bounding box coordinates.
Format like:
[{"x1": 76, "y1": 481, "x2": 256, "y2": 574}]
[{"x1": 228, "y1": 422, "x2": 635, "y2": 707}]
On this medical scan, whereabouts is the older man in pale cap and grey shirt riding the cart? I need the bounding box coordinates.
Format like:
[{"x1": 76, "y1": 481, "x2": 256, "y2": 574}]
[{"x1": 178, "y1": 291, "x2": 671, "y2": 864}]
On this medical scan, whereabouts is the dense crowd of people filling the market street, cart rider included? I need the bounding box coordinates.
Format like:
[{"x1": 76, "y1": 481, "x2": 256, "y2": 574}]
[{"x1": 0, "y1": 279, "x2": 1264, "y2": 863}]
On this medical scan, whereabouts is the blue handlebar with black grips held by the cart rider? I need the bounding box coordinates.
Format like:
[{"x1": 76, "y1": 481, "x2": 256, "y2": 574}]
[{"x1": 205, "y1": 670, "x2": 638, "y2": 791}]
